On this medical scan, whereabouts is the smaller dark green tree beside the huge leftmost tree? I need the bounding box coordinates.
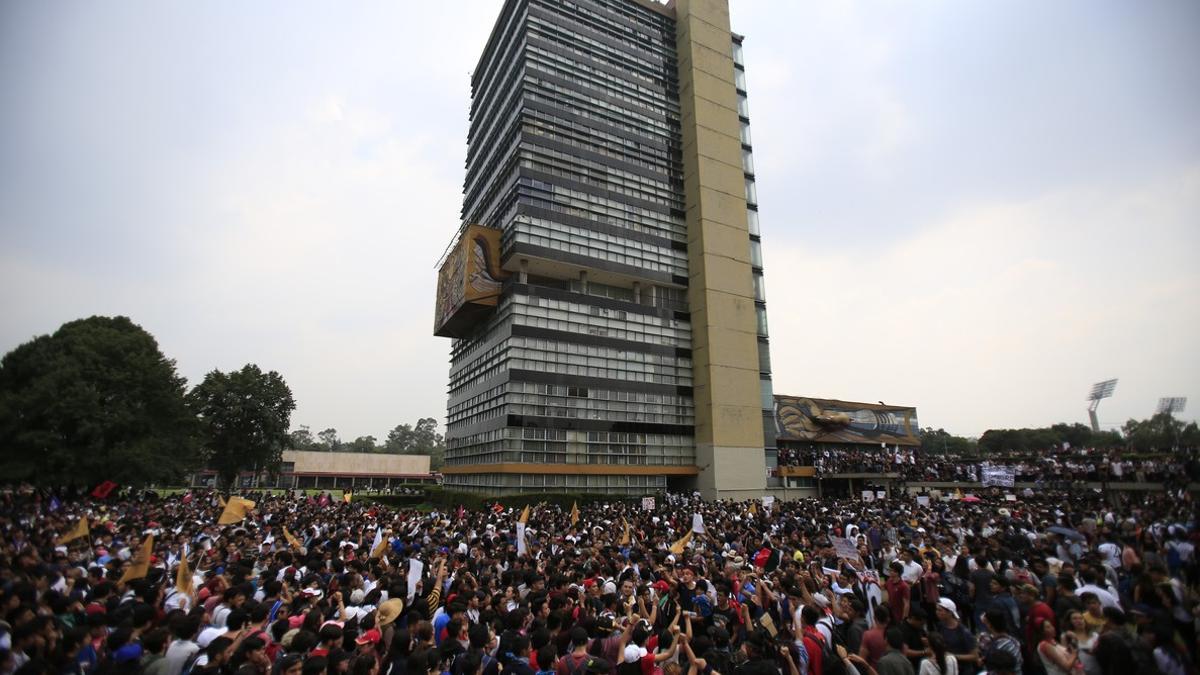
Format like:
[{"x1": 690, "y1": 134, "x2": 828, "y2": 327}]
[{"x1": 187, "y1": 364, "x2": 296, "y2": 486}]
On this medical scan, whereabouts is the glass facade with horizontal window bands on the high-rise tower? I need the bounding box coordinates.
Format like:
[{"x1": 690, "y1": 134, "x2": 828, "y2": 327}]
[{"x1": 445, "y1": 0, "x2": 774, "y2": 494}]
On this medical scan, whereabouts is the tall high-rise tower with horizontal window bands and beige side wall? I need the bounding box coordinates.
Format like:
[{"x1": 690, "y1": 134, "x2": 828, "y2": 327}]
[{"x1": 434, "y1": 0, "x2": 776, "y2": 496}]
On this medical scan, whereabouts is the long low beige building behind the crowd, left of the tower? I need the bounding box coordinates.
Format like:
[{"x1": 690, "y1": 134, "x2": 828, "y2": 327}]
[{"x1": 192, "y1": 450, "x2": 437, "y2": 490}]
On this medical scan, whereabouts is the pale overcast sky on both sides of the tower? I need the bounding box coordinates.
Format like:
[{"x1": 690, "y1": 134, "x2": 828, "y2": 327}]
[{"x1": 0, "y1": 0, "x2": 1200, "y2": 440}]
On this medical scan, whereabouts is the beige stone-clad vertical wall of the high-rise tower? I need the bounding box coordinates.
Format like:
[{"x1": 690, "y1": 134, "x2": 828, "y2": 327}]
[{"x1": 674, "y1": 0, "x2": 766, "y2": 497}]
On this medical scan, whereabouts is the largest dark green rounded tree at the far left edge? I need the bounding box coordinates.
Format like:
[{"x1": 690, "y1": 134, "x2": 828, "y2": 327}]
[{"x1": 0, "y1": 316, "x2": 198, "y2": 485}]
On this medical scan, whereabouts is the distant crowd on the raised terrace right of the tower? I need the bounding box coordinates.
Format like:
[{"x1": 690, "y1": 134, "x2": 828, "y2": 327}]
[{"x1": 779, "y1": 446, "x2": 1200, "y2": 483}]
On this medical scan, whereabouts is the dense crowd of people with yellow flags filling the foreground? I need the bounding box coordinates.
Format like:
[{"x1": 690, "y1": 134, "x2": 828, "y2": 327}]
[{"x1": 0, "y1": 480, "x2": 1200, "y2": 675}]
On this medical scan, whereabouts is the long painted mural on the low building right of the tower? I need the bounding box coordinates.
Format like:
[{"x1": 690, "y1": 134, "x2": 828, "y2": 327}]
[{"x1": 775, "y1": 396, "x2": 920, "y2": 446}]
